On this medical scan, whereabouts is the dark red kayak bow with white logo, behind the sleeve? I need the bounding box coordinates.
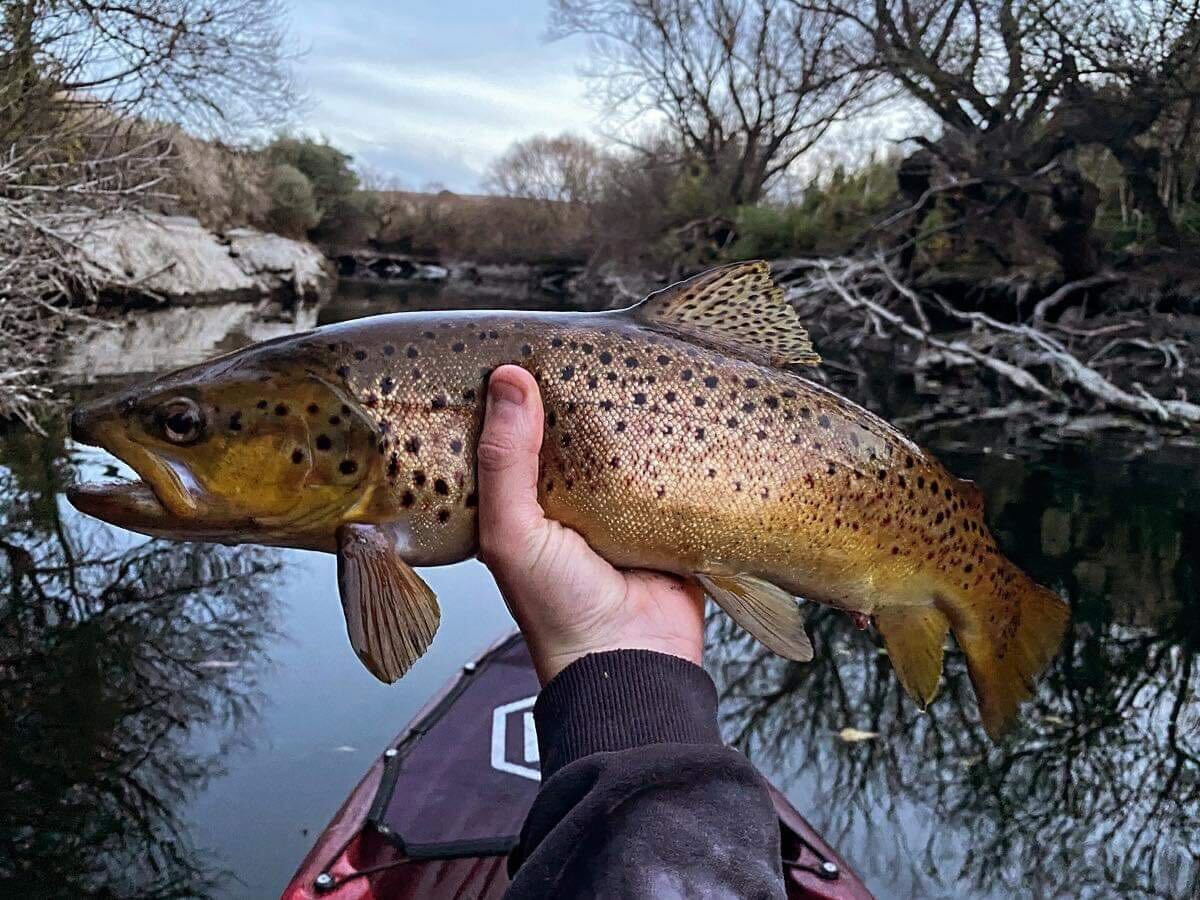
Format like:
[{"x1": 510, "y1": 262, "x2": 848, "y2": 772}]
[{"x1": 283, "y1": 635, "x2": 871, "y2": 900}]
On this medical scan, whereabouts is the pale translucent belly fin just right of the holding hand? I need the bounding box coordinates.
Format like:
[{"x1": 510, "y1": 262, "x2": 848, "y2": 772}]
[{"x1": 696, "y1": 572, "x2": 812, "y2": 662}]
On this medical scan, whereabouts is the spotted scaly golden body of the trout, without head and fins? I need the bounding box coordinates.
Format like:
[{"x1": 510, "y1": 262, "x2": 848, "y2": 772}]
[{"x1": 340, "y1": 316, "x2": 995, "y2": 613}]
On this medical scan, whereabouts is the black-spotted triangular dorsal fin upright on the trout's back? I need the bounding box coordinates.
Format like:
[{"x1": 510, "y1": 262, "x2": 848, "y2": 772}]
[{"x1": 629, "y1": 259, "x2": 821, "y2": 367}]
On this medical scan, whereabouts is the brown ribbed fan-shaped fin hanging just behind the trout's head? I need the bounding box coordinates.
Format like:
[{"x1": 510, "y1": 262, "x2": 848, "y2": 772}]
[{"x1": 337, "y1": 524, "x2": 442, "y2": 684}]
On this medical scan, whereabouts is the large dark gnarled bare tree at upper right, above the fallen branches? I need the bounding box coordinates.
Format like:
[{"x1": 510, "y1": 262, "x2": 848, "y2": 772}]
[{"x1": 802, "y1": 0, "x2": 1200, "y2": 278}]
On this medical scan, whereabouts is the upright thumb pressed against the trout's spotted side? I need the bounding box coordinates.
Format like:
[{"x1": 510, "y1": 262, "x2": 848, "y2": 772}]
[{"x1": 476, "y1": 366, "x2": 545, "y2": 558}]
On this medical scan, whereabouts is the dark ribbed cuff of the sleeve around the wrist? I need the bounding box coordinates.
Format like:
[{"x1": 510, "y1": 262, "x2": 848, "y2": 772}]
[{"x1": 533, "y1": 650, "x2": 724, "y2": 781}]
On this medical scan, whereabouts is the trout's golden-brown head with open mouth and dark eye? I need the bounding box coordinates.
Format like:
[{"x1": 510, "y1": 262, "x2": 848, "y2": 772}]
[{"x1": 68, "y1": 352, "x2": 382, "y2": 550}]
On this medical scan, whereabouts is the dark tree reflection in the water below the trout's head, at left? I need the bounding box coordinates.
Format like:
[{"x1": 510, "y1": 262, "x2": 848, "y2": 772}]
[{"x1": 0, "y1": 438, "x2": 278, "y2": 898}]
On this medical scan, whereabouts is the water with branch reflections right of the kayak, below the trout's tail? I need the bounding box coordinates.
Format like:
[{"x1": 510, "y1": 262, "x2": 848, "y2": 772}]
[{"x1": 709, "y1": 448, "x2": 1200, "y2": 898}]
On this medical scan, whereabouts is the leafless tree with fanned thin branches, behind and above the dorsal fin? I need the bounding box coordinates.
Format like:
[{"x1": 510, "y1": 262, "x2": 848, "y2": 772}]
[{"x1": 551, "y1": 0, "x2": 871, "y2": 205}]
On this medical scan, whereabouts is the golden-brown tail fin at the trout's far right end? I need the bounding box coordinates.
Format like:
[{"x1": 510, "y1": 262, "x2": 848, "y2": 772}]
[{"x1": 937, "y1": 571, "x2": 1070, "y2": 740}]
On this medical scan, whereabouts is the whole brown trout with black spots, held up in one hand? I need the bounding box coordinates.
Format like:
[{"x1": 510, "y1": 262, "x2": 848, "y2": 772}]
[{"x1": 68, "y1": 260, "x2": 1068, "y2": 738}]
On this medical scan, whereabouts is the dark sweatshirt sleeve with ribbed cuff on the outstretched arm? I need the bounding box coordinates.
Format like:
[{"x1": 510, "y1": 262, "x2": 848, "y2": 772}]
[{"x1": 506, "y1": 650, "x2": 785, "y2": 900}]
